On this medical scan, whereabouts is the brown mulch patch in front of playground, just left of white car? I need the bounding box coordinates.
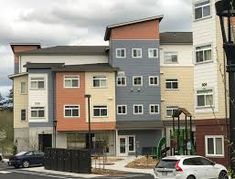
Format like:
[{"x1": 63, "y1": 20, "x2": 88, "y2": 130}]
[{"x1": 125, "y1": 157, "x2": 159, "y2": 169}]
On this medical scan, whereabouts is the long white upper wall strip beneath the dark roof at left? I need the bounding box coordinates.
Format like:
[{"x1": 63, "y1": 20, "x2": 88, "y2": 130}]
[{"x1": 19, "y1": 55, "x2": 108, "y2": 72}]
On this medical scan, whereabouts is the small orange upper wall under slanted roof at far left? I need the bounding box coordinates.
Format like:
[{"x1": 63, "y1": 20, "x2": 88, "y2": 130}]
[{"x1": 11, "y1": 45, "x2": 39, "y2": 74}]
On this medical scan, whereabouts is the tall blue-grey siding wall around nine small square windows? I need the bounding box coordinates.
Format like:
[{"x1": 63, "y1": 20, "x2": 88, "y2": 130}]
[{"x1": 110, "y1": 40, "x2": 161, "y2": 122}]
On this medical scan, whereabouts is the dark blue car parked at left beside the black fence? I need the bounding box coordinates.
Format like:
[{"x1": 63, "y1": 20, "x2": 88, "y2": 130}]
[{"x1": 8, "y1": 151, "x2": 44, "y2": 168}]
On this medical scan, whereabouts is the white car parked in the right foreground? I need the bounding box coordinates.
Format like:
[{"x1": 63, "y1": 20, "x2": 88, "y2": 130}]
[{"x1": 154, "y1": 155, "x2": 228, "y2": 179}]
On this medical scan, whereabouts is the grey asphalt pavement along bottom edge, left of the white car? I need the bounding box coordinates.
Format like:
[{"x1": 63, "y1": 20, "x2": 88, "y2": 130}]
[{"x1": 0, "y1": 162, "x2": 154, "y2": 179}]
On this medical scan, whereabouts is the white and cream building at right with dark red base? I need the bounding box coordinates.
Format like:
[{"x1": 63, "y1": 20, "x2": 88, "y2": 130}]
[{"x1": 192, "y1": 0, "x2": 229, "y2": 165}]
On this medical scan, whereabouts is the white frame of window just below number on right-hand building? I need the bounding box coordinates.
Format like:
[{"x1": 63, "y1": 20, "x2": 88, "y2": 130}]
[{"x1": 196, "y1": 88, "x2": 215, "y2": 109}]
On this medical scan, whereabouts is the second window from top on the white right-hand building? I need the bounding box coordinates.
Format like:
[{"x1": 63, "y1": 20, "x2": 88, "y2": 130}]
[{"x1": 196, "y1": 45, "x2": 212, "y2": 63}]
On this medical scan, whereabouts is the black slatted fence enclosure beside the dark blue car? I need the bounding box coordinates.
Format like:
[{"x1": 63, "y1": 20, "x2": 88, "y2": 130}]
[{"x1": 44, "y1": 148, "x2": 91, "y2": 173}]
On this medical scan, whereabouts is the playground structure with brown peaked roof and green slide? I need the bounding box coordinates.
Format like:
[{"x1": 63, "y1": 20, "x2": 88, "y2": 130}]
[{"x1": 156, "y1": 108, "x2": 196, "y2": 159}]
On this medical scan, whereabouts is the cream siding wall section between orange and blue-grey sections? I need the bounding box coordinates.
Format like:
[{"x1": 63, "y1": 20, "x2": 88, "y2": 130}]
[{"x1": 85, "y1": 72, "x2": 116, "y2": 123}]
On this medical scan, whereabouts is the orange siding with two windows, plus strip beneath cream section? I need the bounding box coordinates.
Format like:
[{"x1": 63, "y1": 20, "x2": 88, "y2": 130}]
[{"x1": 56, "y1": 72, "x2": 115, "y2": 132}]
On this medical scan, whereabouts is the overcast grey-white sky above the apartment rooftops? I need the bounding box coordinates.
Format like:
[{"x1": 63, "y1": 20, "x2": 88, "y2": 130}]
[{"x1": 0, "y1": 0, "x2": 192, "y2": 96}]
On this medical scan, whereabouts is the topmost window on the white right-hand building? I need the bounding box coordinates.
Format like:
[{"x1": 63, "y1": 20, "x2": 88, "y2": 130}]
[{"x1": 194, "y1": 0, "x2": 211, "y2": 20}]
